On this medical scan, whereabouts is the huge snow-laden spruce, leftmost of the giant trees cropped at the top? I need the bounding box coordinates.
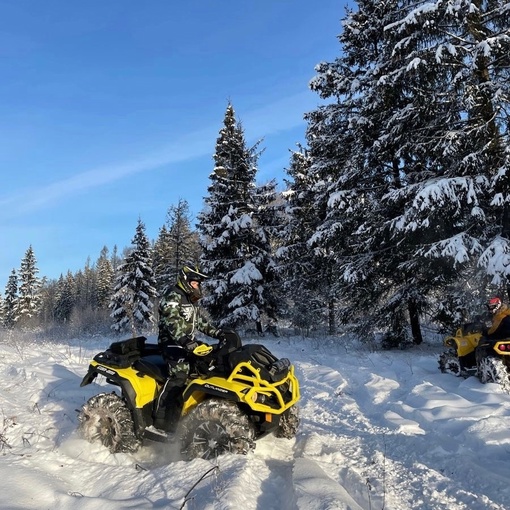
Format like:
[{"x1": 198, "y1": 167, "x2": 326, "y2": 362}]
[{"x1": 307, "y1": 1, "x2": 438, "y2": 342}]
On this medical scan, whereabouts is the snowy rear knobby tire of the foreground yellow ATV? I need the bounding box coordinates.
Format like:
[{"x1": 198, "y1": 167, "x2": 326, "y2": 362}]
[{"x1": 78, "y1": 393, "x2": 140, "y2": 453}]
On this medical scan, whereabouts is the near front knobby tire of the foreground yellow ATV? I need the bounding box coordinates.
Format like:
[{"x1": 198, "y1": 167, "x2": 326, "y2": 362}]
[{"x1": 179, "y1": 398, "x2": 255, "y2": 460}]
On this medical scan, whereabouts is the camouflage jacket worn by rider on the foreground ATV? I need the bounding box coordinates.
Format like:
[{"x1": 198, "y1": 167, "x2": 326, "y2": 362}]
[{"x1": 158, "y1": 286, "x2": 220, "y2": 347}]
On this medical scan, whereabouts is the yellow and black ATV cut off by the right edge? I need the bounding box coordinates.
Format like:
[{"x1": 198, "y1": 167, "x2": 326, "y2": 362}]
[{"x1": 439, "y1": 322, "x2": 510, "y2": 393}]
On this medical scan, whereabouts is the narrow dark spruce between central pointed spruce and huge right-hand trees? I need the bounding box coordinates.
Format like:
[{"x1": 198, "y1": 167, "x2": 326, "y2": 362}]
[{"x1": 275, "y1": 147, "x2": 329, "y2": 333}]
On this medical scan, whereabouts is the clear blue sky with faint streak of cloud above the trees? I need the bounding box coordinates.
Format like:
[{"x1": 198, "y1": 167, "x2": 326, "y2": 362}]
[{"x1": 0, "y1": 0, "x2": 346, "y2": 288}]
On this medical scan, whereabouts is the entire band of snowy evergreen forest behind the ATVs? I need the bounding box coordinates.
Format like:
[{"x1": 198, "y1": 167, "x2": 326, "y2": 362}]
[{"x1": 0, "y1": 0, "x2": 510, "y2": 347}]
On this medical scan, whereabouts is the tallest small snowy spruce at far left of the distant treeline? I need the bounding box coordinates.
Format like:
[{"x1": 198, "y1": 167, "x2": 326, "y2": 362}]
[{"x1": 18, "y1": 246, "x2": 41, "y2": 327}]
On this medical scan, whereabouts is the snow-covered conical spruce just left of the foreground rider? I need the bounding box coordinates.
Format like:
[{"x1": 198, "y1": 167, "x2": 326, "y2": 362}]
[{"x1": 110, "y1": 219, "x2": 157, "y2": 337}]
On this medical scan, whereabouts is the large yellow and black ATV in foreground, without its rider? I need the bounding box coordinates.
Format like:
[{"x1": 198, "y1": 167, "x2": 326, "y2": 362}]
[{"x1": 78, "y1": 337, "x2": 300, "y2": 459}]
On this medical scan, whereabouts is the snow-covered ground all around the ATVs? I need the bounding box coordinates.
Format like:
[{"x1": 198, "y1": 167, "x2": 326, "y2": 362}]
[{"x1": 0, "y1": 333, "x2": 510, "y2": 510}]
